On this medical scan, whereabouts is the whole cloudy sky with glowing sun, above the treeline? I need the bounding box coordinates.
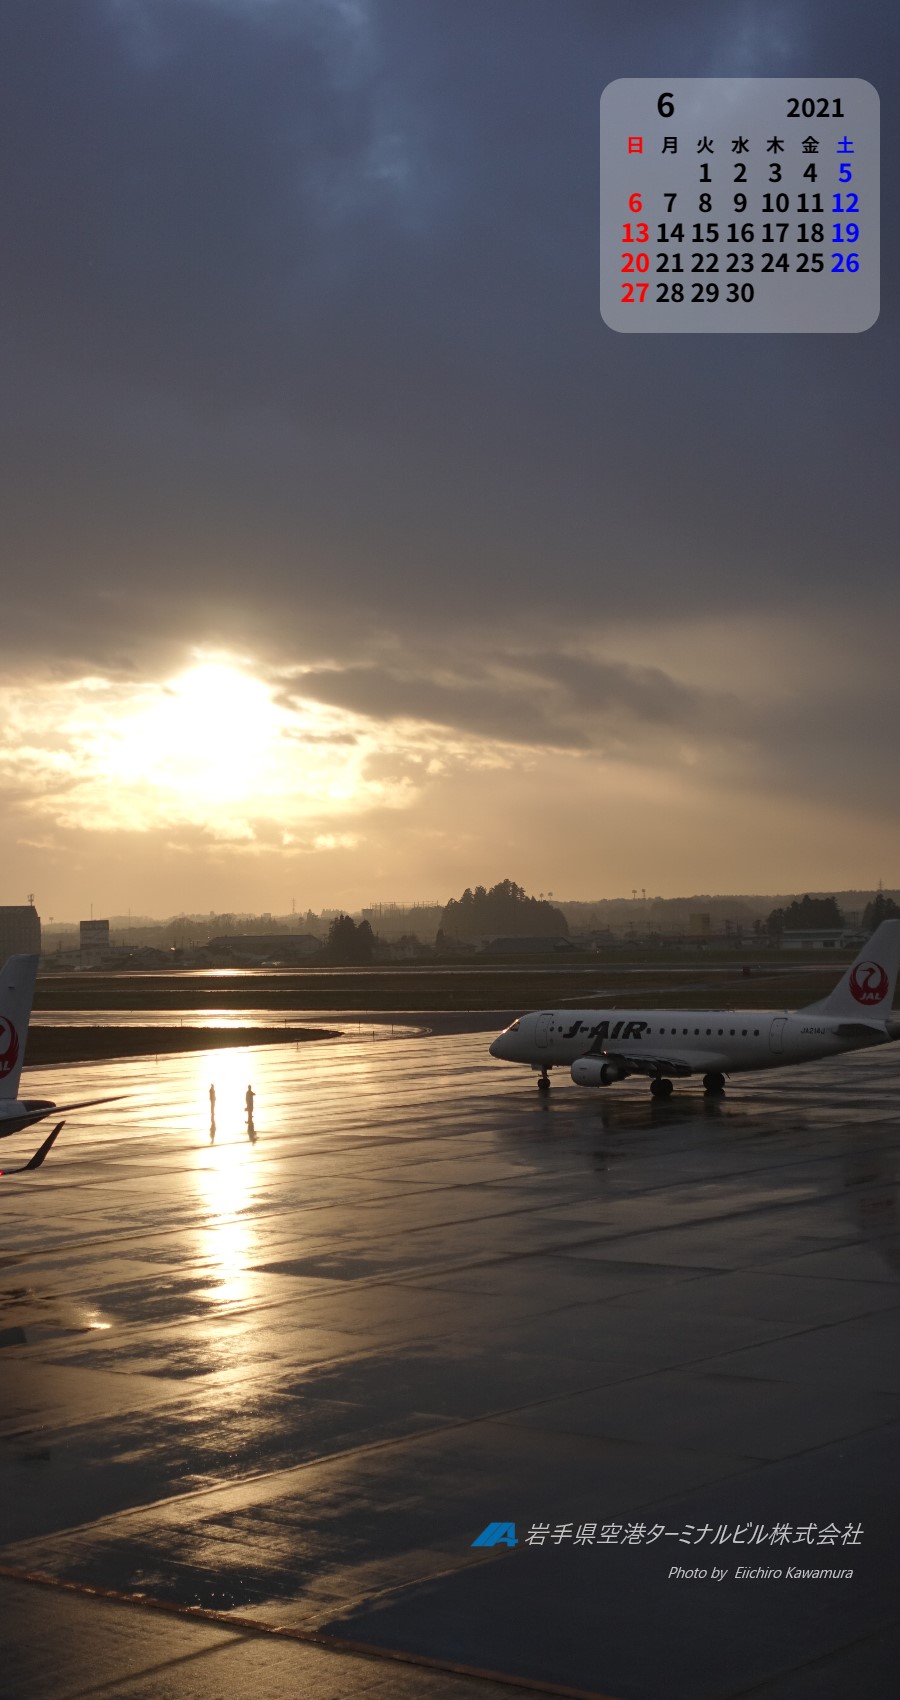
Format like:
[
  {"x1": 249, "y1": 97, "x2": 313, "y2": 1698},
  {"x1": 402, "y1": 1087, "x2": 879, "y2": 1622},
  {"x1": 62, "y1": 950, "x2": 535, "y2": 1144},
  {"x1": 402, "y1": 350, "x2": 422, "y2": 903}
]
[{"x1": 0, "y1": 0, "x2": 900, "y2": 918}]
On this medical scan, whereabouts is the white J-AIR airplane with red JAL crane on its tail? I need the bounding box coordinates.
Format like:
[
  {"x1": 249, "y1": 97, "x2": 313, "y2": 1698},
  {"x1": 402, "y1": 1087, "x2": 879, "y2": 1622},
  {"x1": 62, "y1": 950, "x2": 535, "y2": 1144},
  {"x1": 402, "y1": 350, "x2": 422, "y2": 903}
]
[{"x1": 490, "y1": 920, "x2": 900, "y2": 1098}]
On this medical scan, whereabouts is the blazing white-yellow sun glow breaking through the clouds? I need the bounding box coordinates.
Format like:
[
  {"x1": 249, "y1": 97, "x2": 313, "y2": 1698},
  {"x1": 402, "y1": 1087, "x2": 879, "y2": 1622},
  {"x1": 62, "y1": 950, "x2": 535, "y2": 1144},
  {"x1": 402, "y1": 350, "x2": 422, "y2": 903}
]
[{"x1": 19, "y1": 649, "x2": 427, "y2": 848}]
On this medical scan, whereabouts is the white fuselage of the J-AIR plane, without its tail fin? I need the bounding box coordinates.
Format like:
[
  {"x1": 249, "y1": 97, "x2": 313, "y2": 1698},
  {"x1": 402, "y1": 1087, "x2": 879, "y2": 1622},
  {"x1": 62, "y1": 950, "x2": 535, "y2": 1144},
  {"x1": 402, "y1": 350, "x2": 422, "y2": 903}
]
[{"x1": 490, "y1": 1010, "x2": 900, "y2": 1074}]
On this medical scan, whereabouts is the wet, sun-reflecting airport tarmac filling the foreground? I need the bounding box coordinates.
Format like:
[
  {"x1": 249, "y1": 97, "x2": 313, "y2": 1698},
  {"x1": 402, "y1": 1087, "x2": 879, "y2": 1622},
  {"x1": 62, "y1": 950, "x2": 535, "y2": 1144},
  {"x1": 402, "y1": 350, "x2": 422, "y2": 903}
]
[{"x1": 0, "y1": 1034, "x2": 900, "y2": 1700}]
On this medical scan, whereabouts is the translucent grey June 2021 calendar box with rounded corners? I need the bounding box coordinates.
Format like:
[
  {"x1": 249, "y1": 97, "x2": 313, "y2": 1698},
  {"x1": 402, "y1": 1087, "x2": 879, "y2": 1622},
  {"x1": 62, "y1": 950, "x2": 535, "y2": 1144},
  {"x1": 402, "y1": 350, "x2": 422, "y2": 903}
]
[{"x1": 601, "y1": 77, "x2": 880, "y2": 332}]
